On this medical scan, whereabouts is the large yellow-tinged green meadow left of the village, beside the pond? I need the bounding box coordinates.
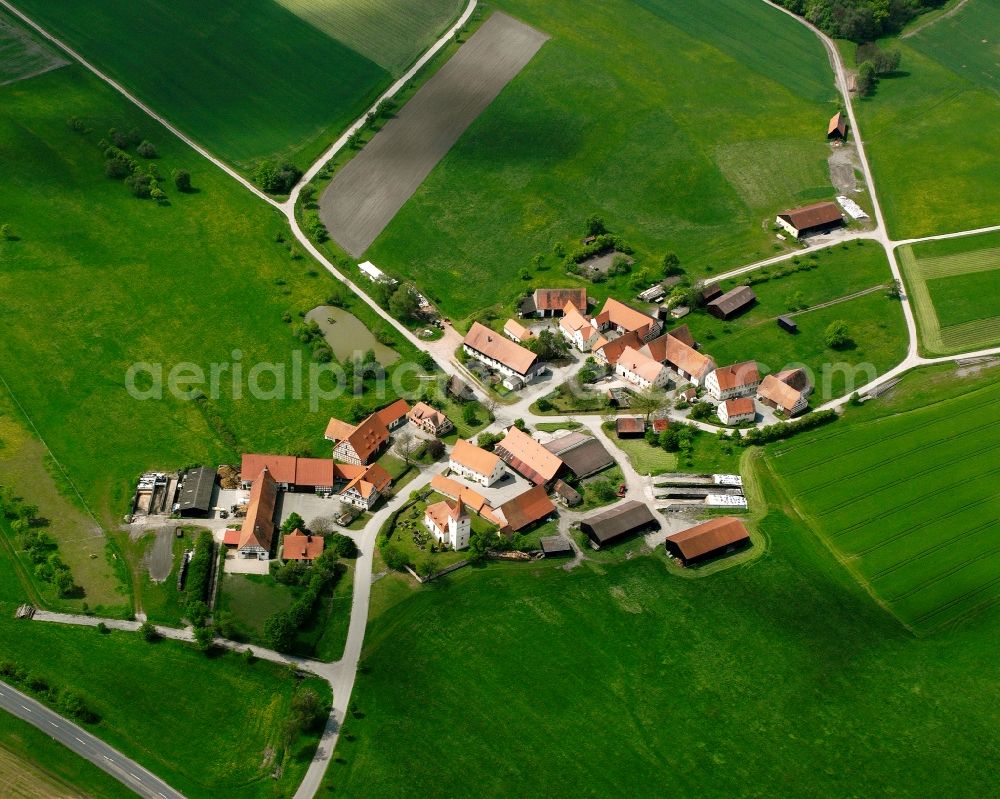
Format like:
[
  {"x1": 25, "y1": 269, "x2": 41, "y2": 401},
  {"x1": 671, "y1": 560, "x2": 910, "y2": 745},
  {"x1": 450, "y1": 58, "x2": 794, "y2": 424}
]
[{"x1": 0, "y1": 67, "x2": 416, "y2": 525}]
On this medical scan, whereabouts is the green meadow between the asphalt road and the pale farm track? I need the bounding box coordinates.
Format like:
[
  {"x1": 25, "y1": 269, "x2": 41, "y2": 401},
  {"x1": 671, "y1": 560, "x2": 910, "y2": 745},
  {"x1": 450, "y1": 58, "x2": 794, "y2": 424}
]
[{"x1": 0, "y1": 554, "x2": 329, "y2": 799}]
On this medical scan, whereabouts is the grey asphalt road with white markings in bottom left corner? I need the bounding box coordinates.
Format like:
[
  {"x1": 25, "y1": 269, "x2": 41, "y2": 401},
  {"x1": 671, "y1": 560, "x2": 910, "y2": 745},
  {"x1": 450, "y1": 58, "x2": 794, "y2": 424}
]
[{"x1": 0, "y1": 682, "x2": 184, "y2": 799}]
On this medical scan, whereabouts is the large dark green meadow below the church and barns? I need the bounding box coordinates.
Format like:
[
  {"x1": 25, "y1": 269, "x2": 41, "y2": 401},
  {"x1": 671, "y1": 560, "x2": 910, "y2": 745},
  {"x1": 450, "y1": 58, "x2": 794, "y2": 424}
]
[{"x1": 326, "y1": 456, "x2": 1000, "y2": 799}]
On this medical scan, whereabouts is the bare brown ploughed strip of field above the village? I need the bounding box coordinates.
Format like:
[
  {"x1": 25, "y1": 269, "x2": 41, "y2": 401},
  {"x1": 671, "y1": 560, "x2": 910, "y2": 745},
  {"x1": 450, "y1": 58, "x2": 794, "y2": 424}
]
[{"x1": 320, "y1": 13, "x2": 548, "y2": 257}]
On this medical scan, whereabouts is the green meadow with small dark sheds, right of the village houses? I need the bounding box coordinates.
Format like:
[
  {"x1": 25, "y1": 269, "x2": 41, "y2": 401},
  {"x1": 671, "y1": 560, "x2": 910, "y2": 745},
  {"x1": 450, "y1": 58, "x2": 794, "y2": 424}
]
[{"x1": 681, "y1": 242, "x2": 907, "y2": 403}]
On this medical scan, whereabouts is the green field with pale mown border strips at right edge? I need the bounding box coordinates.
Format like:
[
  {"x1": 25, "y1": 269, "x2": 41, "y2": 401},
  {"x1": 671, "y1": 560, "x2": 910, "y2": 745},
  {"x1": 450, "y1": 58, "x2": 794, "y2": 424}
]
[{"x1": 899, "y1": 233, "x2": 1000, "y2": 355}]
